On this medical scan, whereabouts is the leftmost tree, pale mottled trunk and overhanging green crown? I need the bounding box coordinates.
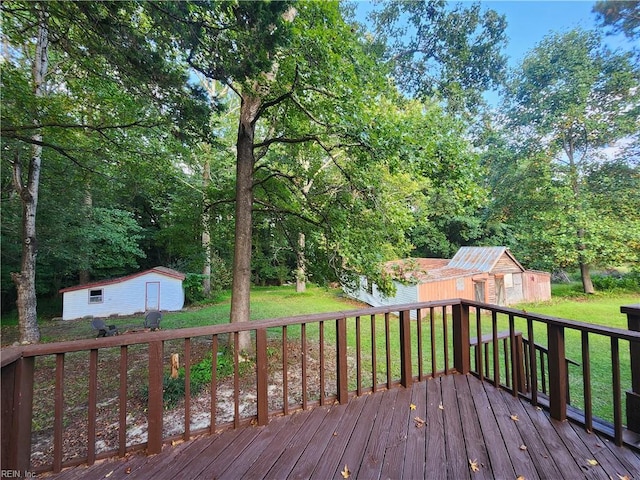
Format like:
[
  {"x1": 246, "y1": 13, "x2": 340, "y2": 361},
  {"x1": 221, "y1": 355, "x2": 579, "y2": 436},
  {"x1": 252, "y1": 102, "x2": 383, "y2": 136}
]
[{"x1": 1, "y1": 1, "x2": 208, "y2": 342}]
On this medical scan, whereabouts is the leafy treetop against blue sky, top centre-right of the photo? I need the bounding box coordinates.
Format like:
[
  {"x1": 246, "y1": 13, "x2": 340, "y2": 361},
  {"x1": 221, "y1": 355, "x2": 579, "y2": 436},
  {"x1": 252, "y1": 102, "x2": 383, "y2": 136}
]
[{"x1": 371, "y1": 0, "x2": 506, "y2": 113}]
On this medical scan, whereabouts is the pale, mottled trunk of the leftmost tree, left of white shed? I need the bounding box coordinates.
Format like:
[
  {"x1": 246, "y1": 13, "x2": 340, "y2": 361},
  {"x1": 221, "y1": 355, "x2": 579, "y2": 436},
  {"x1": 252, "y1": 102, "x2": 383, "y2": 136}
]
[{"x1": 12, "y1": 7, "x2": 49, "y2": 343}]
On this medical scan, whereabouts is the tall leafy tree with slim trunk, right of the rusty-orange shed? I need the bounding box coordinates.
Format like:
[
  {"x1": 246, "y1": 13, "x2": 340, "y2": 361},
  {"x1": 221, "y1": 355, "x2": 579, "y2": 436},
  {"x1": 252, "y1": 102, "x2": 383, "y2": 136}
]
[{"x1": 507, "y1": 30, "x2": 640, "y2": 293}]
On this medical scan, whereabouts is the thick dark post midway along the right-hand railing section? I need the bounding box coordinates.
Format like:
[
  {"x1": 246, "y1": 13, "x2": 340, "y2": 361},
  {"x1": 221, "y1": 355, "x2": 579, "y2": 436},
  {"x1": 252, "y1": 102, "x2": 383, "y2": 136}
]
[{"x1": 547, "y1": 323, "x2": 568, "y2": 421}]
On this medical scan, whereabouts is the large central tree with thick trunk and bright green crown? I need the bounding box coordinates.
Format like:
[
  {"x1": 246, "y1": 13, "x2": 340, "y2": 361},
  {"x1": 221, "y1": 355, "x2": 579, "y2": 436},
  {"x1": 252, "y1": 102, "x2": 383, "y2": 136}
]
[{"x1": 153, "y1": 2, "x2": 392, "y2": 338}]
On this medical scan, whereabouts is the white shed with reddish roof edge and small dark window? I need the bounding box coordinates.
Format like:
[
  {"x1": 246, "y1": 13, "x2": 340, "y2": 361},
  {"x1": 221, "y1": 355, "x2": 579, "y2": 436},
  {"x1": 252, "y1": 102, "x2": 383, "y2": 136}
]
[{"x1": 60, "y1": 267, "x2": 185, "y2": 320}]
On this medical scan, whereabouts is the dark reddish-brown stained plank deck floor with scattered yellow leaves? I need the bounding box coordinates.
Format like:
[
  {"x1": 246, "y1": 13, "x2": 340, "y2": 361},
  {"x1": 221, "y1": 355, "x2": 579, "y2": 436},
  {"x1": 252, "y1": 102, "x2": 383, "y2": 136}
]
[{"x1": 45, "y1": 375, "x2": 640, "y2": 480}]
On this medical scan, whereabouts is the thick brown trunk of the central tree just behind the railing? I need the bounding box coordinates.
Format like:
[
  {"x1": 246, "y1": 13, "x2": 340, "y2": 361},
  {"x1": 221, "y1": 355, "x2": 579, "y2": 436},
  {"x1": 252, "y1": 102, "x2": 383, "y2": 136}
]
[{"x1": 231, "y1": 95, "x2": 260, "y2": 350}]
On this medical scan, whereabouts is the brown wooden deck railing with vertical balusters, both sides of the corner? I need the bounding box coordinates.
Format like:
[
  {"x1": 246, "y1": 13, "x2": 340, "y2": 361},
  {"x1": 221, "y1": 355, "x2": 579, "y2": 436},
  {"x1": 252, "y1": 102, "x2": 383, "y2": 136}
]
[{"x1": 1, "y1": 300, "x2": 640, "y2": 472}]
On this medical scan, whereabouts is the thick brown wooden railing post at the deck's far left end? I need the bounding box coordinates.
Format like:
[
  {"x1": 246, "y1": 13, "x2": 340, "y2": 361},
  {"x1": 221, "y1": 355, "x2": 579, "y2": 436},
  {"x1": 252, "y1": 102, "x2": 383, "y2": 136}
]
[{"x1": 2, "y1": 357, "x2": 34, "y2": 472}]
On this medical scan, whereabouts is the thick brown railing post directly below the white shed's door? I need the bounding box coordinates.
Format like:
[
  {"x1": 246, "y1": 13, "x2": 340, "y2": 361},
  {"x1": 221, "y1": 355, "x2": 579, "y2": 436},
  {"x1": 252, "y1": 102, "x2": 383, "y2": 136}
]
[{"x1": 147, "y1": 341, "x2": 164, "y2": 455}]
